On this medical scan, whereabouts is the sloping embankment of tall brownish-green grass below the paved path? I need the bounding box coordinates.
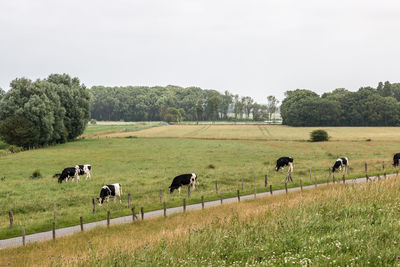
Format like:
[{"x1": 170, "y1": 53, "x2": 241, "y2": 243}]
[{"x1": 0, "y1": 177, "x2": 400, "y2": 266}]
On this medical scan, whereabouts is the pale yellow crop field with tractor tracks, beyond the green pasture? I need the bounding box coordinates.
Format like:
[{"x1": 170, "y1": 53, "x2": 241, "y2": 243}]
[{"x1": 105, "y1": 125, "x2": 400, "y2": 142}]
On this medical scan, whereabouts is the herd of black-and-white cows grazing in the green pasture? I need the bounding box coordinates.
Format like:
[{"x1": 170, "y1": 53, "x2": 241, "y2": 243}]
[{"x1": 53, "y1": 153, "x2": 400, "y2": 206}]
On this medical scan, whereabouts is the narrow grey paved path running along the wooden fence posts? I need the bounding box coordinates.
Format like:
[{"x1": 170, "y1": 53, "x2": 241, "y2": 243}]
[{"x1": 0, "y1": 174, "x2": 396, "y2": 249}]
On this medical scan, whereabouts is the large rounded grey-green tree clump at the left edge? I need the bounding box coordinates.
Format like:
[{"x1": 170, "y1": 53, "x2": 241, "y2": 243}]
[{"x1": 0, "y1": 74, "x2": 90, "y2": 148}]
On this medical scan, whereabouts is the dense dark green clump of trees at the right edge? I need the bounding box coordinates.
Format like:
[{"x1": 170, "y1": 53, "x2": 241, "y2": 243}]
[{"x1": 281, "y1": 81, "x2": 400, "y2": 126}]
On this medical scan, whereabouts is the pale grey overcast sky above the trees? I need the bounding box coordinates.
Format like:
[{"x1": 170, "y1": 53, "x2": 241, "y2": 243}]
[{"x1": 0, "y1": 0, "x2": 400, "y2": 102}]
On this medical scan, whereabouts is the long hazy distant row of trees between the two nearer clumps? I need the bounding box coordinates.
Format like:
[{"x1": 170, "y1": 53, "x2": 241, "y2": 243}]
[{"x1": 90, "y1": 85, "x2": 278, "y2": 122}]
